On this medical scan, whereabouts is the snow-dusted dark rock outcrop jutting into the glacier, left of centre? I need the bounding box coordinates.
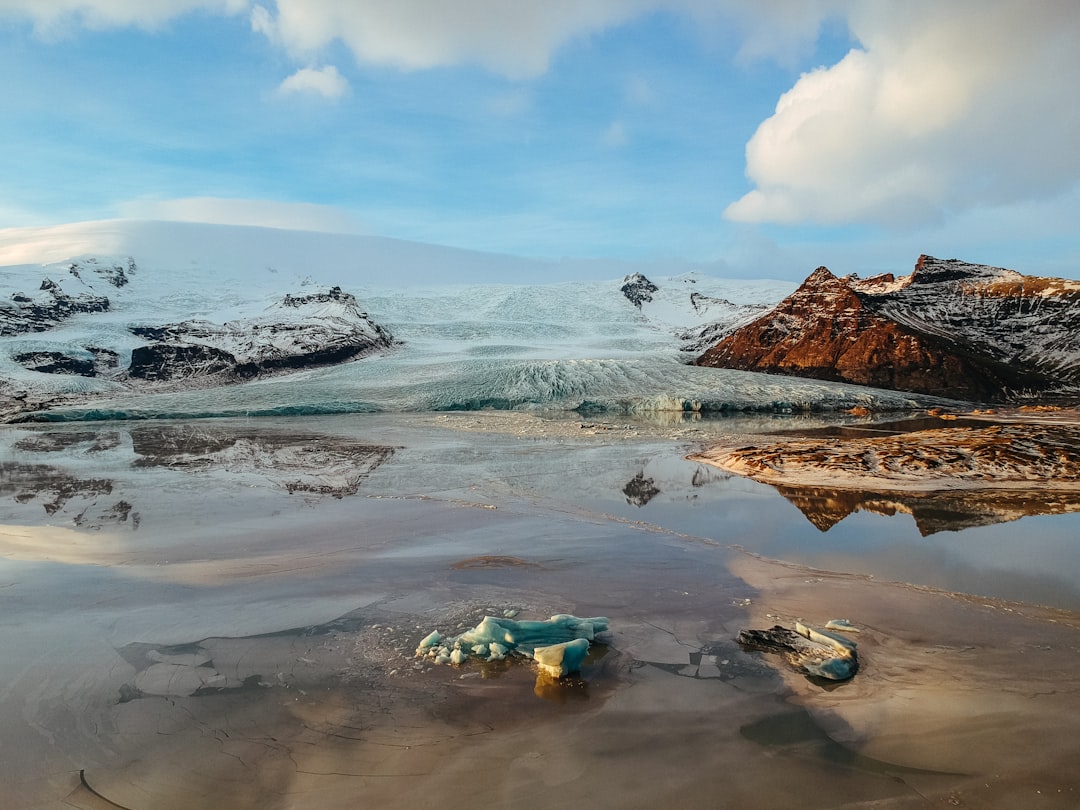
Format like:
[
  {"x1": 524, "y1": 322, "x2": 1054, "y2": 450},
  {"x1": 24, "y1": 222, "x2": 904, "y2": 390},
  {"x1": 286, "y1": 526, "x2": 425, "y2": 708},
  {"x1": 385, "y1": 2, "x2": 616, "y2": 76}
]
[{"x1": 127, "y1": 287, "x2": 393, "y2": 382}]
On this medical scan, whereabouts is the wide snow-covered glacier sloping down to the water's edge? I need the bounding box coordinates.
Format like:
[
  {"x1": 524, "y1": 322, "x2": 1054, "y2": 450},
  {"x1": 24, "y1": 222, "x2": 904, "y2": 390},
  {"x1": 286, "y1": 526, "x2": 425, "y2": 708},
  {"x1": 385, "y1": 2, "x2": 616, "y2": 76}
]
[{"x1": 0, "y1": 222, "x2": 946, "y2": 420}]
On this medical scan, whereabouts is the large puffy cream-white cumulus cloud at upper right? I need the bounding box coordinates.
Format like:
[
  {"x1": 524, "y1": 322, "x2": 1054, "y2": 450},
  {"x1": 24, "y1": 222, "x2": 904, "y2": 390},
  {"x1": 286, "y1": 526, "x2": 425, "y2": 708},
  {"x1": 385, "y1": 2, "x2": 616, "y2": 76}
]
[{"x1": 726, "y1": 0, "x2": 1080, "y2": 227}]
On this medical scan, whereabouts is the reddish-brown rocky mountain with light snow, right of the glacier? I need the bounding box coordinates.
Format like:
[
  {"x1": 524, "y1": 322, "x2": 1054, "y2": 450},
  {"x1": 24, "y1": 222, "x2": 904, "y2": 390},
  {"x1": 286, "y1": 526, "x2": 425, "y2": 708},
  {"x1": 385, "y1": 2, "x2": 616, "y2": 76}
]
[{"x1": 696, "y1": 256, "x2": 1080, "y2": 402}]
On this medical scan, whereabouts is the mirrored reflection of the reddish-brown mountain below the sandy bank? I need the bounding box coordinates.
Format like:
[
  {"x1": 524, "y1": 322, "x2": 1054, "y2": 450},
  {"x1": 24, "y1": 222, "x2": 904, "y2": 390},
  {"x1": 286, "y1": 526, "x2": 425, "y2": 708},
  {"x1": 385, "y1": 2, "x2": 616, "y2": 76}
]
[{"x1": 775, "y1": 485, "x2": 1080, "y2": 537}]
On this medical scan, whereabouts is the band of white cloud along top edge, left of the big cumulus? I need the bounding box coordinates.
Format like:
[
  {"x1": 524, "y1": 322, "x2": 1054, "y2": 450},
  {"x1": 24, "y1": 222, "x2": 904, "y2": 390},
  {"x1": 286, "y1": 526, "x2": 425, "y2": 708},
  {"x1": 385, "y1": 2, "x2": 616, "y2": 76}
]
[{"x1": 0, "y1": 0, "x2": 829, "y2": 79}]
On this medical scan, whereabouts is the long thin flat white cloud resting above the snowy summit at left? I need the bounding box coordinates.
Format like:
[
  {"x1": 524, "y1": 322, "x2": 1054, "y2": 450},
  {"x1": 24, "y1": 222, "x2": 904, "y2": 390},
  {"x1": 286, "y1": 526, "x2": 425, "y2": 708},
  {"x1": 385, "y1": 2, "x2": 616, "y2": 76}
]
[{"x1": 119, "y1": 197, "x2": 364, "y2": 233}]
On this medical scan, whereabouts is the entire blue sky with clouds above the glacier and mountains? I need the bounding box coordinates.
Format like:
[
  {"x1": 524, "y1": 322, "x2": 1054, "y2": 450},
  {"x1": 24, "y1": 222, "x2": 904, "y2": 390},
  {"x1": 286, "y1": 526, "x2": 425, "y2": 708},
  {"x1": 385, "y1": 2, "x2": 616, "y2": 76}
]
[{"x1": 0, "y1": 0, "x2": 1080, "y2": 280}]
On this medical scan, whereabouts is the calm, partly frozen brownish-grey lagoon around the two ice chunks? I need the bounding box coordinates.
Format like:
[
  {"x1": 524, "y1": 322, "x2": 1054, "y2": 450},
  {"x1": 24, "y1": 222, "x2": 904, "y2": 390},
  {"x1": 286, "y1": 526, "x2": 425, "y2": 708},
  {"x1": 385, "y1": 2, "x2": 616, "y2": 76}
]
[{"x1": 0, "y1": 415, "x2": 1080, "y2": 810}]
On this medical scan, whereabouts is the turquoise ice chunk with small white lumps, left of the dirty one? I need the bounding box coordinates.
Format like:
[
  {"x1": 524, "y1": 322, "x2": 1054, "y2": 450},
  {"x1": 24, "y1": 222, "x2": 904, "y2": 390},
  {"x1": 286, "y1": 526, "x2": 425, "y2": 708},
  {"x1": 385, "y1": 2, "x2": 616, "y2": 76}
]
[{"x1": 416, "y1": 613, "x2": 608, "y2": 678}]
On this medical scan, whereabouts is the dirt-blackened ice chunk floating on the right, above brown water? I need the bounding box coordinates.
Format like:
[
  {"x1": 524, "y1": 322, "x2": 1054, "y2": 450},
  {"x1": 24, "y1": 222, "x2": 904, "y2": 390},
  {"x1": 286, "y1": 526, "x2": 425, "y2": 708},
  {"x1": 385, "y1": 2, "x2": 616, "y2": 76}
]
[{"x1": 739, "y1": 619, "x2": 859, "y2": 680}]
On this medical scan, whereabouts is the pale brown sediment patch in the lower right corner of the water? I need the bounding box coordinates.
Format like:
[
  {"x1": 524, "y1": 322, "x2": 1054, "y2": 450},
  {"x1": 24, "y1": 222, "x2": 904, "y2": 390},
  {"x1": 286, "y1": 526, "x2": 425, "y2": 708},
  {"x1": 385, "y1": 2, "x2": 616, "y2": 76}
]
[{"x1": 731, "y1": 554, "x2": 1080, "y2": 807}]
